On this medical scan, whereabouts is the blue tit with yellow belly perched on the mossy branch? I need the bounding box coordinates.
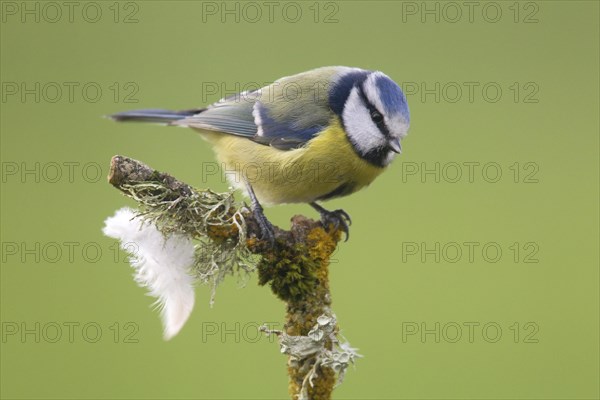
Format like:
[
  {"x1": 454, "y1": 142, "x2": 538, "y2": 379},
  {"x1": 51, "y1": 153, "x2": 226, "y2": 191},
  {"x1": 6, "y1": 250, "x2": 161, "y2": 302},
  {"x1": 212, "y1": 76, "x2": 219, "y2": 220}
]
[{"x1": 112, "y1": 66, "x2": 410, "y2": 239}]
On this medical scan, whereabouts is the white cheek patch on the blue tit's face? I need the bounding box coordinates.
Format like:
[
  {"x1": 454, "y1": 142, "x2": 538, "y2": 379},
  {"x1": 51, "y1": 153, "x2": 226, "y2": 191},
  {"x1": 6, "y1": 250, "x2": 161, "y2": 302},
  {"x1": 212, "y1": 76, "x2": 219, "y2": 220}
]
[{"x1": 342, "y1": 88, "x2": 386, "y2": 153}]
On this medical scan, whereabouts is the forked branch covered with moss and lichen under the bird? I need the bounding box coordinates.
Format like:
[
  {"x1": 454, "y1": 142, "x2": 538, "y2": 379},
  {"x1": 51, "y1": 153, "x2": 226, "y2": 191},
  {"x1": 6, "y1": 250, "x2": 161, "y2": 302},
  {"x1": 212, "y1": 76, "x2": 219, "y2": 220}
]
[{"x1": 108, "y1": 156, "x2": 357, "y2": 400}]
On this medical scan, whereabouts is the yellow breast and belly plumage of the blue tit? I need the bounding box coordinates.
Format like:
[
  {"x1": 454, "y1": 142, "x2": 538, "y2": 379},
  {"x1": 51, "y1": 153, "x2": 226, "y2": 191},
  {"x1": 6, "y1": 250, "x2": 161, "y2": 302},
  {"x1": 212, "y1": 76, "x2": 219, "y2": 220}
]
[{"x1": 199, "y1": 117, "x2": 383, "y2": 204}]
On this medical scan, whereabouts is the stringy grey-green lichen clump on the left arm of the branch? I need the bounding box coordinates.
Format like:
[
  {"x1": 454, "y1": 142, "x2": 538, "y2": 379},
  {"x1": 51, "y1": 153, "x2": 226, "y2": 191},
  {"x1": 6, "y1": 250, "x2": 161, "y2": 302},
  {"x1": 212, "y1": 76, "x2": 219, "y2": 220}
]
[{"x1": 116, "y1": 180, "x2": 260, "y2": 304}]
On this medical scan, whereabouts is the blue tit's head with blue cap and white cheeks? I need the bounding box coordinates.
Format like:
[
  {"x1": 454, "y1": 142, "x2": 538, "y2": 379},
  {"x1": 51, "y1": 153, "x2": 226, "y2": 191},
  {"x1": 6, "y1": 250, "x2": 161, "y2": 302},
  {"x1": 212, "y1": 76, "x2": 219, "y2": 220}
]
[{"x1": 329, "y1": 69, "x2": 410, "y2": 167}]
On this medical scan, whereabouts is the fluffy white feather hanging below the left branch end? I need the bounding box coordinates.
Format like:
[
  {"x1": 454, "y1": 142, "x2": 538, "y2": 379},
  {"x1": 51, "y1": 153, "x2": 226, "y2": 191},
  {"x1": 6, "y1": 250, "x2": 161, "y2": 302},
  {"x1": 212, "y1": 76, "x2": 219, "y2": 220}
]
[{"x1": 102, "y1": 207, "x2": 194, "y2": 340}]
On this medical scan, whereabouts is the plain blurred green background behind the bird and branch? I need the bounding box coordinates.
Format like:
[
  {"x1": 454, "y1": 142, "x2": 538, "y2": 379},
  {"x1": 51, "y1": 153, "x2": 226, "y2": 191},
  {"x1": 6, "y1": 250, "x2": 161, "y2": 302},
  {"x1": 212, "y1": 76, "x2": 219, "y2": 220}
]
[{"x1": 0, "y1": 1, "x2": 599, "y2": 399}]
